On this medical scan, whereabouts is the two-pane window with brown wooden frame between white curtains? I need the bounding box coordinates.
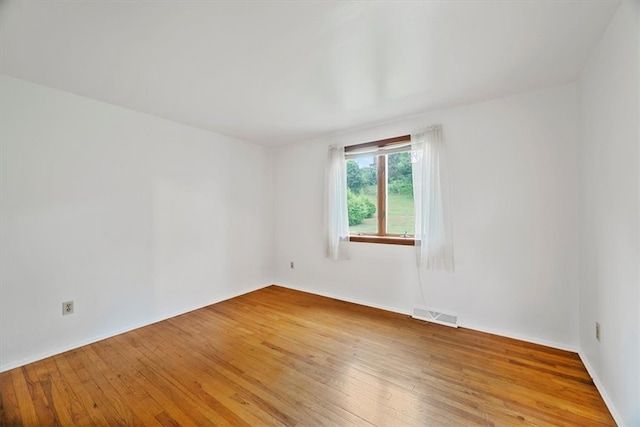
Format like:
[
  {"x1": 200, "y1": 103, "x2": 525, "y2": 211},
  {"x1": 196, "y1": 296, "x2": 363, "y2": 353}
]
[{"x1": 345, "y1": 135, "x2": 414, "y2": 245}]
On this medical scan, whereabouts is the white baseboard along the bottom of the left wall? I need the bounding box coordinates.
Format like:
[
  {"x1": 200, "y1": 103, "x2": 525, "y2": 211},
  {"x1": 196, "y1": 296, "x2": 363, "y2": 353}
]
[{"x1": 0, "y1": 284, "x2": 270, "y2": 372}]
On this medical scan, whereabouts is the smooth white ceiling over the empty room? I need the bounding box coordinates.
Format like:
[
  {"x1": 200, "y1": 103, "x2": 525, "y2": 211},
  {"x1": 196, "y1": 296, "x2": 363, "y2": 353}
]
[{"x1": 0, "y1": 0, "x2": 619, "y2": 145}]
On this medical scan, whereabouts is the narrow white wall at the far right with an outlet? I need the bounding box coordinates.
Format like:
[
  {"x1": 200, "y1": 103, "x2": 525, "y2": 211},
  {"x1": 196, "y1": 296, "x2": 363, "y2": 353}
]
[{"x1": 579, "y1": 1, "x2": 640, "y2": 426}]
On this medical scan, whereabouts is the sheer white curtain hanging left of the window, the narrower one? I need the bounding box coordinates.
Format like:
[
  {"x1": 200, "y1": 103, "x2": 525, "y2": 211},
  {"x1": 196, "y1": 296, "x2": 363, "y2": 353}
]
[{"x1": 325, "y1": 146, "x2": 349, "y2": 260}]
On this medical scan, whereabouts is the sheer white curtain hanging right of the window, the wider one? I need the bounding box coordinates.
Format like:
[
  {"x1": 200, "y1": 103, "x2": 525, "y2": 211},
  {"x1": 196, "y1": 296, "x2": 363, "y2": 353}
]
[{"x1": 411, "y1": 125, "x2": 454, "y2": 271}]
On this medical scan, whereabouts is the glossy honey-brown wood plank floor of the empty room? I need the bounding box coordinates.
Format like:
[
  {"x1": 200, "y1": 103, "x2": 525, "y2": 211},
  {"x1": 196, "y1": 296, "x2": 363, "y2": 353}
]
[{"x1": 0, "y1": 286, "x2": 615, "y2": 427}]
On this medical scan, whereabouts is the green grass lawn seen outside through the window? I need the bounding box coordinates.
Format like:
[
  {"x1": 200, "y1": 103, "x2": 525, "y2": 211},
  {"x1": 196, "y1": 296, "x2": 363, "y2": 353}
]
[{"x1": 349, "y1": 191, "x2": 414, "y2": 234}]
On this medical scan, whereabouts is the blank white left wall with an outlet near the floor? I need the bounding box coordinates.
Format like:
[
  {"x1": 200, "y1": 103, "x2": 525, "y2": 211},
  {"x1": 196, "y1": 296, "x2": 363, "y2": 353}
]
[{"x1": 0, "y1": 76, "x2": 273, "y2": 370}]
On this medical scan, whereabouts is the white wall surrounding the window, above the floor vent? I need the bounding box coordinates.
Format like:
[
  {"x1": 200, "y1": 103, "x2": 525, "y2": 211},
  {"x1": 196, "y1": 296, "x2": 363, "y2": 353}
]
[{"x1": 274, "y1": 84, "x2": 578, "y2": 349}]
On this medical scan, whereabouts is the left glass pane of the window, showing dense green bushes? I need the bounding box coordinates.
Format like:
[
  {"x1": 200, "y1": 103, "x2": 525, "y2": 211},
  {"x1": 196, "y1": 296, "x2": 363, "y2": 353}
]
[{"x1": 347, "y1": 156, "x2": 378, "y2": 233}]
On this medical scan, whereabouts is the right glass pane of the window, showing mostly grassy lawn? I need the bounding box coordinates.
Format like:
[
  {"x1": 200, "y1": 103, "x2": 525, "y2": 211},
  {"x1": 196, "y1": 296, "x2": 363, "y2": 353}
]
[{"x1": 387, "y1": 152, "x2": 415, "y2": 234}]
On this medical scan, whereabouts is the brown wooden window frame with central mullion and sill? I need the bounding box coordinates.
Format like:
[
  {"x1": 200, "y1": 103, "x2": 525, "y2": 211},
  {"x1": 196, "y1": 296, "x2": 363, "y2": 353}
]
[{"x1": 344, "y1": 135, "x2": 415, "y2": 246}]
